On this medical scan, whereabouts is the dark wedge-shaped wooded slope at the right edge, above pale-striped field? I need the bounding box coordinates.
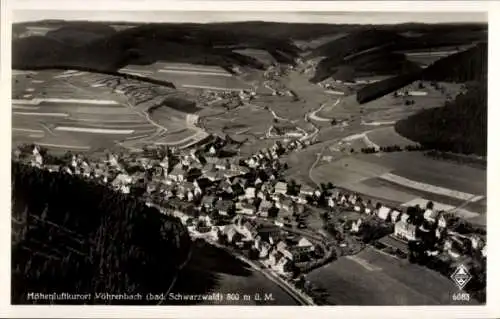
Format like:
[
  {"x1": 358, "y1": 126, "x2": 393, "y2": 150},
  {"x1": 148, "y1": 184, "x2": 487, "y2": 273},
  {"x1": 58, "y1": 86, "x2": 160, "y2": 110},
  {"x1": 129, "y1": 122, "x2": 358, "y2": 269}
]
[{"x1": 395, "y1": 82, "x2": 488, "y2": 156}]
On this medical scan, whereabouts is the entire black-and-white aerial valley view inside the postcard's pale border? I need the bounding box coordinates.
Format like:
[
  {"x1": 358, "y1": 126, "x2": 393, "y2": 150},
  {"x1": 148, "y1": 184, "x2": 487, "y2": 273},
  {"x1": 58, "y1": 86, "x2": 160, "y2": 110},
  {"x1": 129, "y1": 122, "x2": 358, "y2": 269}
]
[{"x1": 11, "y1": 10, "x2": 488, "y2": 306}]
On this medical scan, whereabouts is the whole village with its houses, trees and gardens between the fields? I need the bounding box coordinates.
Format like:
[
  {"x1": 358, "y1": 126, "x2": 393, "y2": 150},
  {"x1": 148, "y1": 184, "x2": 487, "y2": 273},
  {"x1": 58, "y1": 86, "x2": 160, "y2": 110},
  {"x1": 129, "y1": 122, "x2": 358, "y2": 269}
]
[{"x1": 13, "y1": 130, "x2": 486, "y2": 302}]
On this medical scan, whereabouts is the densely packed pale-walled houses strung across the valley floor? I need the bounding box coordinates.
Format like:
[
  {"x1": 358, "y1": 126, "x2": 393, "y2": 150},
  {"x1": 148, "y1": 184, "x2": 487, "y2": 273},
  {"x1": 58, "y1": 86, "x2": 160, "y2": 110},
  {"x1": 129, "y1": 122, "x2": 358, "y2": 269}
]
[{"x1": 16, "y1": 124, "x2": 486, "y2": 272}]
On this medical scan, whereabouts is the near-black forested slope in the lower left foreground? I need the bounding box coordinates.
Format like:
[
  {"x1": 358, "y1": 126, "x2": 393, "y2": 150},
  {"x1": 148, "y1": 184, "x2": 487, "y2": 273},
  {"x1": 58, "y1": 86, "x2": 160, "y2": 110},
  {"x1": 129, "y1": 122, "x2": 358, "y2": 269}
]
[{"x1": 12, "y1": 162, "x2": 191, "y2": 304}]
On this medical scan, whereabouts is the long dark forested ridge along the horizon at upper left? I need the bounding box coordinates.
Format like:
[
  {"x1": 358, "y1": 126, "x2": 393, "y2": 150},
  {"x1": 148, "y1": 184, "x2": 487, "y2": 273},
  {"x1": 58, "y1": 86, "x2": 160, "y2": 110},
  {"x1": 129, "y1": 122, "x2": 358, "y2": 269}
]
[{"x1": 12, "y1": 24, "x2": 299, "y2": 71}]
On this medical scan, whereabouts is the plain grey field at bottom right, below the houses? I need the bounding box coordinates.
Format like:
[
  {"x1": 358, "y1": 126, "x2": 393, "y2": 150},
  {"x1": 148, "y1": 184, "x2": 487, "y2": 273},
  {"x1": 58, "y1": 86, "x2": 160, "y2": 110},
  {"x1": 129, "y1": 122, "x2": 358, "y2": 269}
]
[{"x1": 308, "y1": 248, "x2": 477, "y2": 306}]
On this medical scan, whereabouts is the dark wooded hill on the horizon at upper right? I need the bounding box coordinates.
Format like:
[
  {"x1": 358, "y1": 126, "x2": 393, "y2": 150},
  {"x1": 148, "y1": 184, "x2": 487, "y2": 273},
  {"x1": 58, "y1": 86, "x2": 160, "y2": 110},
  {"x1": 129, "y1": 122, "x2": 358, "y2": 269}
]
[{"x1": 306, "y1": 25, "x2": 487, "y2": 83}]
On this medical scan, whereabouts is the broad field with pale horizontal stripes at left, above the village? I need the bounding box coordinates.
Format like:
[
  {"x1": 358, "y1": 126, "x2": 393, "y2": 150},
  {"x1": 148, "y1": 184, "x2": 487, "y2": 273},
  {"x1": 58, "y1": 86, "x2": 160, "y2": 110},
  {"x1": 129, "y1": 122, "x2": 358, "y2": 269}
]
[{"x1": 12, "y1": 71, "x2": 205, "y2": 151}]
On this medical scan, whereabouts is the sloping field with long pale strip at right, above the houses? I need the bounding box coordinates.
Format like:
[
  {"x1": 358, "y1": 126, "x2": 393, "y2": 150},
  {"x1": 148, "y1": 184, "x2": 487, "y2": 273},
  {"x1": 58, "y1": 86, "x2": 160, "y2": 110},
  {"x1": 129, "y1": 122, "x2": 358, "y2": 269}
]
[{"x1": 311, "y1": 152, "x2": 486, "y2": 225}]
